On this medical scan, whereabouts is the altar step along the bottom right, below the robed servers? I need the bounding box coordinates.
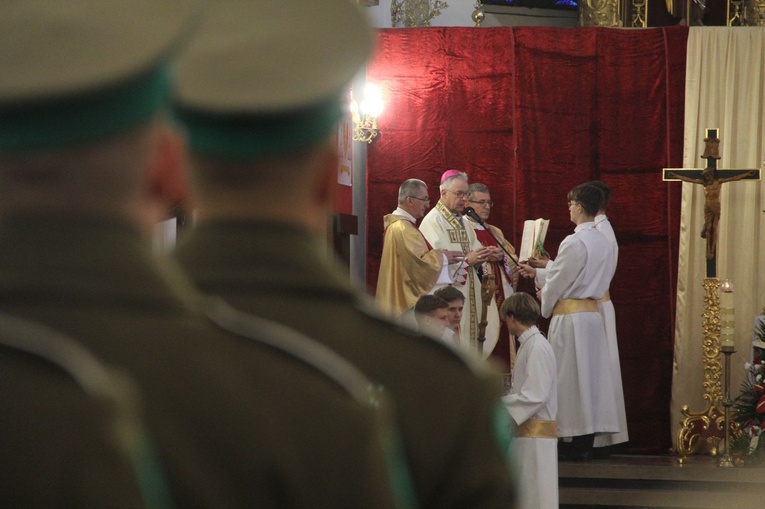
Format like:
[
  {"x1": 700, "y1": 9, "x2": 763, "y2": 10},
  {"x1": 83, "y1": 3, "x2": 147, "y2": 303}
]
[{"x1": 558, "y1": 456, "x2": 765, "y2": 509}]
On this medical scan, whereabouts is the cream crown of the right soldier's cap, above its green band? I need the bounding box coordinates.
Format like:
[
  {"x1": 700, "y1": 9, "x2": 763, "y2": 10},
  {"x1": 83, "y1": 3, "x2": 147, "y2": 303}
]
[{"x1": 174, "y1": 0, "x2": 374, "y2": 115}]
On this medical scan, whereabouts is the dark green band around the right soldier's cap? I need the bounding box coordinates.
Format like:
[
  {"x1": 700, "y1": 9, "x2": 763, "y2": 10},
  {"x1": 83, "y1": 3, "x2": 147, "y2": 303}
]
[{"x1": 175, "y1": 97, "x2": 342, "y2": 160}]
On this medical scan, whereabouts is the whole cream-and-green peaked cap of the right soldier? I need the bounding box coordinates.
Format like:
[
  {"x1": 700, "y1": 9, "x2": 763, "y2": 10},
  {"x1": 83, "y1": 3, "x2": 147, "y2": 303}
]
[{"x1": 174, "y1": 0, "x2": 374, "y2": 158}]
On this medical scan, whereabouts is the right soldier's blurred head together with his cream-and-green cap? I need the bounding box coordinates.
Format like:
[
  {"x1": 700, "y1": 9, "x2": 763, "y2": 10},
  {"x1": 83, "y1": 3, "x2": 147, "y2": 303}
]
[{"x1": 174, "y1": 0, "x2": 374, "y2": 232}]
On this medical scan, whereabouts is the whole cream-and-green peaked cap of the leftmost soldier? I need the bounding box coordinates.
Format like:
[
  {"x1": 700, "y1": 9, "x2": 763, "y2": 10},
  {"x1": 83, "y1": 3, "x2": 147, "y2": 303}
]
[{"x1": 0, "y1": 0, "x2": 200, "y2": 152}]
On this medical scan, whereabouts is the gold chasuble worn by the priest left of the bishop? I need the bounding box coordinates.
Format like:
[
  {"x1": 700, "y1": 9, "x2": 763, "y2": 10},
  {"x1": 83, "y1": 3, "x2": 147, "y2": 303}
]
[{"x1": 375, "y1": 214, "x2": 444, "y2": 318}]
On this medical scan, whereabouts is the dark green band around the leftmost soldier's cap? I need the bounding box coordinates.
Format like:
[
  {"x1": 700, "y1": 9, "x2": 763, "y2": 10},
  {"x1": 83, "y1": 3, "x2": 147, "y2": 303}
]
[{"x1": 0, "y1": 65, "x2": 170, "y2": 153}]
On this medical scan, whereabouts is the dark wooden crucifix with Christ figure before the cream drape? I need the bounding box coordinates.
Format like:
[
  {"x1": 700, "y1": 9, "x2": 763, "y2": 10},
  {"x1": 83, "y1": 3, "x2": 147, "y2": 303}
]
[{"x1": 662, "y1": 128, "x2": 760, "y2": 277}]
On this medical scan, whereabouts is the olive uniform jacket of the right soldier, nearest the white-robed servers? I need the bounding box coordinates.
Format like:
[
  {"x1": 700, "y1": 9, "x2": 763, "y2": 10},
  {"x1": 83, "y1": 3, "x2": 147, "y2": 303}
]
[{"x1": 176, "y1": 221, "x2": 514, "y2": 509}]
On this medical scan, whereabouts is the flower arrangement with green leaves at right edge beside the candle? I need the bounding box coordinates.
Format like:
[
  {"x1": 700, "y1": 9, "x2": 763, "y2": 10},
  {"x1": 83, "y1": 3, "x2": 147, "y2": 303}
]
[{"x1": 731, "y1": 321, "x2": 765, "y2": 463}]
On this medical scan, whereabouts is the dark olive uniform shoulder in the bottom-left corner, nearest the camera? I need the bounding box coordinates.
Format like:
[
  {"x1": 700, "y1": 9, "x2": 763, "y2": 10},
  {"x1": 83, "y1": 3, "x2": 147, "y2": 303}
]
[{"x1": 0, "y1": 338, "x2": 146, "y2": 509}]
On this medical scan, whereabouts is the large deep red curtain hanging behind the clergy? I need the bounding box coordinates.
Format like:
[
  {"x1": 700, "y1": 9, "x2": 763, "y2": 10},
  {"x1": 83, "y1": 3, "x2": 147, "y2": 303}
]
[{"x1": 366, "y1": 27, "x2": 688, "y2": 453}]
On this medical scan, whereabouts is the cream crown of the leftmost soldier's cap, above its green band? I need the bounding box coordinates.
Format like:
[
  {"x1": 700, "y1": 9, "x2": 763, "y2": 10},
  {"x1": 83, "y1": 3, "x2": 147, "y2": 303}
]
[{"x1": 0, "y1": 0, "x2": 199, "y2": 104}]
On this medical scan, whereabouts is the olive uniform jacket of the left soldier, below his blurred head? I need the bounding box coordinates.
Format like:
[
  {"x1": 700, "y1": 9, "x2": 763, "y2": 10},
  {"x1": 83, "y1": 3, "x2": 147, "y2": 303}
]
[{"x1": 0, "y1": 216, "x2": 396, "y2": 509}]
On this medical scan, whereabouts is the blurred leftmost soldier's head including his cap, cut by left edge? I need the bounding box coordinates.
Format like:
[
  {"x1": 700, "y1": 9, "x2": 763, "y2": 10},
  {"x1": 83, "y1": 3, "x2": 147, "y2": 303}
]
[{"x1": 0, "y1": 0, "x2": 198, "y2": 227}]
